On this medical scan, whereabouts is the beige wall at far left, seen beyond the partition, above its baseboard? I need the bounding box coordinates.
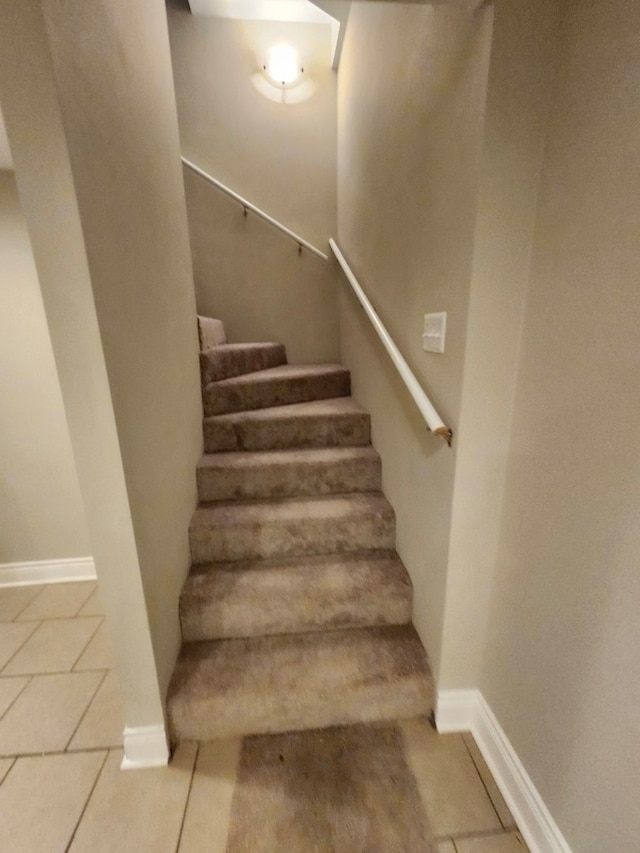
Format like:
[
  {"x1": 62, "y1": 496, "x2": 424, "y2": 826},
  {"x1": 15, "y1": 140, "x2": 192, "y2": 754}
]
[{"x1": 0, "y1": 171, "x2": 91, "y2": 564}]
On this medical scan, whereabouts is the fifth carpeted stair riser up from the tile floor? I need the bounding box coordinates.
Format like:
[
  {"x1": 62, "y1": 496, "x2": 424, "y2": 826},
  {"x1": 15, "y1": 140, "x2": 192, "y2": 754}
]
[{"x1": 204, "y1": 414, "x2": 371, "y2": 453}]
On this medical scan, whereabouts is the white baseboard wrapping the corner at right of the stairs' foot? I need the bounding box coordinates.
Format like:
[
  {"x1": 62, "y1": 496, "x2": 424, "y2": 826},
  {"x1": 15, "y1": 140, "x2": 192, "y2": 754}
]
[{"x1": 436, "y1": 690, "x2": 571, "y2": 853}]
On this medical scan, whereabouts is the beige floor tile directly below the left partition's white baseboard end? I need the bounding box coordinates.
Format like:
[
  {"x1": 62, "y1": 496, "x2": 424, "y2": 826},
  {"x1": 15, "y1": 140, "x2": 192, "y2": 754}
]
[{"x1": 70, "y1": 743, "x2": 196, "y2": 853}]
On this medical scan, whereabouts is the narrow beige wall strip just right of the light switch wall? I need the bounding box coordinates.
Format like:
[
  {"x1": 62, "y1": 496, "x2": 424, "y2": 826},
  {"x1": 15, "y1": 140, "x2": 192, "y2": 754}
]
[{"x1": 439, "y1": 0, "x2": 558, "y2": 689}]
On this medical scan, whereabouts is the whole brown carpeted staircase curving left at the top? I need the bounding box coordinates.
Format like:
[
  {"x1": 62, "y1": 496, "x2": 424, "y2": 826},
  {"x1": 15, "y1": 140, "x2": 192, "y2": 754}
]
[{"x1": 167, "y1": 318, "x2": 433, "y2": 743}]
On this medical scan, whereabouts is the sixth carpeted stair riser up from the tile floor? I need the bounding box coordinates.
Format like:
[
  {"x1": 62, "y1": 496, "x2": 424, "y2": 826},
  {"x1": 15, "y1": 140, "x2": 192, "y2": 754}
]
[{"x1": 203, "y1": 371, "x2": 350, "y2": 417}]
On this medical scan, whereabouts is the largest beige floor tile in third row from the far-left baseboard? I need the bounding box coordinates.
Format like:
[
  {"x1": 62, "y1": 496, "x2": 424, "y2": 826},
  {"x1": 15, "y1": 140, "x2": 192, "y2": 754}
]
[{"x1": 0, "y1": 672, "x2": 102, "y2": 752}]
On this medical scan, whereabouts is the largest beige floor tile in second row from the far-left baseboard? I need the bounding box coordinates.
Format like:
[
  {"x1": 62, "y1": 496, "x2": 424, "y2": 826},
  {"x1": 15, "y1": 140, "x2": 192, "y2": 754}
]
[{"x1": 0, "y1": 616, "x2": 100, "y2": 675}]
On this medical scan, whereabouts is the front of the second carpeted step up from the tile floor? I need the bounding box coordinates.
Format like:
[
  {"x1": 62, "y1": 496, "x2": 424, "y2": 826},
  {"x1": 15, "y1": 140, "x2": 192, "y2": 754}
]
[{"x1": 180, "y1": 558, "x2": 412, "y2": 642}]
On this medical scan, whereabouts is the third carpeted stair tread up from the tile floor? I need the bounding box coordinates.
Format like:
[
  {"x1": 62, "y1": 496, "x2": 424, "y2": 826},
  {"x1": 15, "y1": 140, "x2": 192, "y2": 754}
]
[{"x1": 191, "y1": 492, "x2": 393, "y2": 527}]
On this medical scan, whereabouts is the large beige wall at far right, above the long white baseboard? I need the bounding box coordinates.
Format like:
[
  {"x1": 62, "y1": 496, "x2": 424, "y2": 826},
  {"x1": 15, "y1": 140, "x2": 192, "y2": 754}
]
[{"x1": 480, "y1": 0, "x2": 640, "y2": 853}]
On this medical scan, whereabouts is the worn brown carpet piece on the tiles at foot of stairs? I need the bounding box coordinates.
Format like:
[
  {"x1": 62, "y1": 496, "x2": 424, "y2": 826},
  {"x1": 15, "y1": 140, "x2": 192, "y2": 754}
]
[{"x1": 227, "y1": 725, "x2": 436, "y2": 853}]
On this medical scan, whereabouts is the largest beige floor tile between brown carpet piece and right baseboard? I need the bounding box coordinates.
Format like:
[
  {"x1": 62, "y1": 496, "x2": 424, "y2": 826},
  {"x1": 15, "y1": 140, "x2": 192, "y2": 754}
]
[{"x1": 402, "y1": 720, "x2": 502, "y2": 843}]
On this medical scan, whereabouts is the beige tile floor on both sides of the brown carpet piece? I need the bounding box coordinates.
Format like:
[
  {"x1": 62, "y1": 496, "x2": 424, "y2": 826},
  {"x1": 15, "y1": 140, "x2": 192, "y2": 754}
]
[{"x1": 0, "y1": 582, "x2": 527, "y2": 853}]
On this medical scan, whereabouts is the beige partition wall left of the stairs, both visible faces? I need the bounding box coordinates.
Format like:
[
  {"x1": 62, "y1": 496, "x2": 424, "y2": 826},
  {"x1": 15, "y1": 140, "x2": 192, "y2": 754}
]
[{"x1": 0, "y1": 0, "x2": 201, "y2": 726}]
